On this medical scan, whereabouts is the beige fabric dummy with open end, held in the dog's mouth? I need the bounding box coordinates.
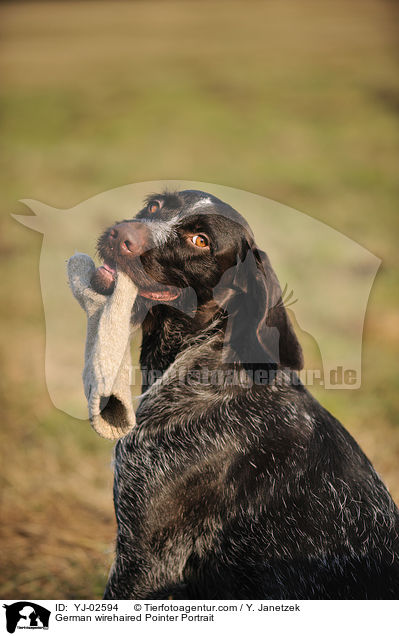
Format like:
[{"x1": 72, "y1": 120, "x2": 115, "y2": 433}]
[{"x1": 68, "y1": 253, "x2": 137, "y2": 440}]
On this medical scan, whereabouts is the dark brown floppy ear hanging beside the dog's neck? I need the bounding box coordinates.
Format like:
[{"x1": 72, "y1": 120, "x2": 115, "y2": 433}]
[{"x1": 219, "y1": 245, "x2": 303, "y2": 369}]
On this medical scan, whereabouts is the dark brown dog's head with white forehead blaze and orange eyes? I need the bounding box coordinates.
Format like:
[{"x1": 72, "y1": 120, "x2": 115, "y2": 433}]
[{"x1": 92, "y1": 190, "x2": 302, "y2": 369}]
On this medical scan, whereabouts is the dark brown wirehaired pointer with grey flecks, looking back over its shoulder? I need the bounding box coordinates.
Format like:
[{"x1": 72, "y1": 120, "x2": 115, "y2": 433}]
[{"x1": 91, "y1": 190, "x2": 399, "y2": 599}]
